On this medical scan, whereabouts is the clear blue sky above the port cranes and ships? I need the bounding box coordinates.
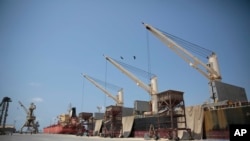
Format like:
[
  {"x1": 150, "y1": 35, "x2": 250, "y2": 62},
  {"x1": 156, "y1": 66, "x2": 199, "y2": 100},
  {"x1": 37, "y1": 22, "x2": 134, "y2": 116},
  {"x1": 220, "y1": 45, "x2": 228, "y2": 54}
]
[{"x1": 0, "y1": 0, "x2": 250, "y2": 130}]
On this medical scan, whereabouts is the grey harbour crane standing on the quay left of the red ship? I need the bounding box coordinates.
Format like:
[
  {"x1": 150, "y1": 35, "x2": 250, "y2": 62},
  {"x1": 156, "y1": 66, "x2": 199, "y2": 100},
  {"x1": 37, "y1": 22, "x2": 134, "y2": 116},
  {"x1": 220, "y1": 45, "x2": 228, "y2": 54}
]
[{"x1": 18, "y1": 101, "x2": 39, "y2": 134}]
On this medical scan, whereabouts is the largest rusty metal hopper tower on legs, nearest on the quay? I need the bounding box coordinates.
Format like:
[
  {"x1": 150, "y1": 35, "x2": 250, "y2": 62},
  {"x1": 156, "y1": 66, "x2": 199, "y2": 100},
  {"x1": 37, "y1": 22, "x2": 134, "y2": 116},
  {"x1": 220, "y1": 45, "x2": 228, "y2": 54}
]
[{"x1": 158, "y1": 90, "x2": 192, "y2": 139}]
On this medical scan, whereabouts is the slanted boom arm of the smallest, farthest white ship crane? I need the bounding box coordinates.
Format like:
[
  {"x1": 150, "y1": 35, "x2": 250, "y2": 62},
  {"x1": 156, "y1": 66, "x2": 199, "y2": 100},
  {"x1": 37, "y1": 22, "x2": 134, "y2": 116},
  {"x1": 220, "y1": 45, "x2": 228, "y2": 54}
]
[{"x1": 82, "y1": 74, "x2": 123, "y2": 106}]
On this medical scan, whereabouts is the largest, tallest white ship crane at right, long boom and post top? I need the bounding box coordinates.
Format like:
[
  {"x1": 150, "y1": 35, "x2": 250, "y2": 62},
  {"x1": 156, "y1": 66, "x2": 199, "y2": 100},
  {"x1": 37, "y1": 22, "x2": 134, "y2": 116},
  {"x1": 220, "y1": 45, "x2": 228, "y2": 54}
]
[{"x1": 143, "y1": 23, "x2": 222, "y2": 101}]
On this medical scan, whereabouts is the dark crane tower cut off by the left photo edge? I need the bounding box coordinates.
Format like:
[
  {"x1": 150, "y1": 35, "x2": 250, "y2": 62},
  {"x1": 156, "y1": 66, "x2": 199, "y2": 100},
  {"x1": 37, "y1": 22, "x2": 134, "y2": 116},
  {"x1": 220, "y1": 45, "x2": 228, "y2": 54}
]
[{"x1": 0, "y1": 97, "x2": 11, "y2": 134}]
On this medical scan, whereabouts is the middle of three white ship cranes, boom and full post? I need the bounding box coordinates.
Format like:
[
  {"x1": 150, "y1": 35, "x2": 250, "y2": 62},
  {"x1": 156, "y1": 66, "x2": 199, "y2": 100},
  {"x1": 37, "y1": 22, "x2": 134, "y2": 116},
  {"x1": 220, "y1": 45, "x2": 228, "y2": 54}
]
[{"x1": 104, "y1": 56, "x2": 158, "y2": 114}]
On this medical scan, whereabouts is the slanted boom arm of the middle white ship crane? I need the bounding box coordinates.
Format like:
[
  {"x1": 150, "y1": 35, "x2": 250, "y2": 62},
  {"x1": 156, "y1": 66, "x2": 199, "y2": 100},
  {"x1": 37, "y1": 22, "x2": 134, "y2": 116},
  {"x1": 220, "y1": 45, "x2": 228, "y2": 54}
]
[{"x1": 104, "y1": 56, "x2": 152, "y2": 95}]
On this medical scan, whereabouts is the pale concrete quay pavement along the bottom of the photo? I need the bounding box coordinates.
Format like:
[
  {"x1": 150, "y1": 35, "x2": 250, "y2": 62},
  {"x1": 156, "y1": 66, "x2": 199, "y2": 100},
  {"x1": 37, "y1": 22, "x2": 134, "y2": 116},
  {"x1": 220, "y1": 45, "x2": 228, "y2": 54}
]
[{"x1": 0, "y1": 133, "x2": 229, "y2": 141}]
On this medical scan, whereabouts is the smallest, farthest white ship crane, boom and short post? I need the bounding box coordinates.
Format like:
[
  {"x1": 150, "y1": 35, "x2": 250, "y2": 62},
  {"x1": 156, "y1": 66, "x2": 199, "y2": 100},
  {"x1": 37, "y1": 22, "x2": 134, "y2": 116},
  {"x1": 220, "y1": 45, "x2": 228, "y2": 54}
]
[{"x1": 82, "y1": 74, "x2": 124, "y2": 106}]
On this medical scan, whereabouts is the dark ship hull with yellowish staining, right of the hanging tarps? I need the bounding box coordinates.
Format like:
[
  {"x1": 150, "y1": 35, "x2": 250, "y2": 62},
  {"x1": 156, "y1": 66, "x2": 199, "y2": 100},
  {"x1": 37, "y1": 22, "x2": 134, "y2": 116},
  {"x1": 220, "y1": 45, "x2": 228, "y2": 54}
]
[{"x1": 203, "y1": 105, "x2": 250, "y2": 139}]
